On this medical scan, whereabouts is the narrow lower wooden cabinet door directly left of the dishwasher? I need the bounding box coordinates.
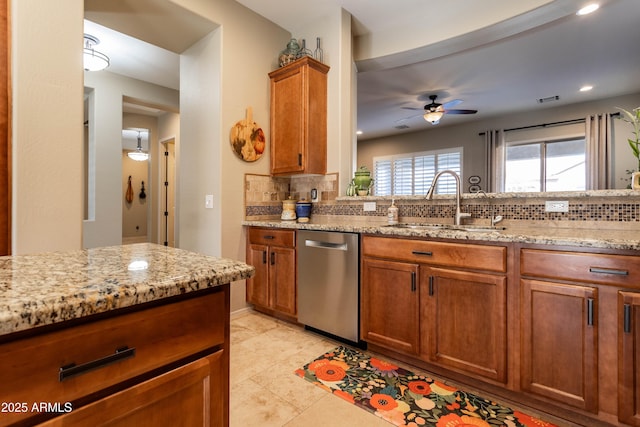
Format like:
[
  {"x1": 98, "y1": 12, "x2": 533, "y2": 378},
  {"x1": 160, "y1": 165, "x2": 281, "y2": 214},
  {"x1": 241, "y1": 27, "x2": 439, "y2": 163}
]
[{"x1": 269, "y1": 246, "x2": 297, "y2": 315}]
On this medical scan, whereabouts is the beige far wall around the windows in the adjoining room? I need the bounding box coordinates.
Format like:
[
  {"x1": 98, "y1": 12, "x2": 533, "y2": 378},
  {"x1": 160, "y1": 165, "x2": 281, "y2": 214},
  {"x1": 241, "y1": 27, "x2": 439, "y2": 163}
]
[{"x1": 358, "y1": 94, "x2": 640, "y2": 188}]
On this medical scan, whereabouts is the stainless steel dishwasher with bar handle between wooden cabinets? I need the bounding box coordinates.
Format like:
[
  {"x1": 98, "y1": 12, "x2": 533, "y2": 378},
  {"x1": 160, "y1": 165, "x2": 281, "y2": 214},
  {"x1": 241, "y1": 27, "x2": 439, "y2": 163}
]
[{"x1": 296, "y1": 230, "x2": 360, "y2": 343}]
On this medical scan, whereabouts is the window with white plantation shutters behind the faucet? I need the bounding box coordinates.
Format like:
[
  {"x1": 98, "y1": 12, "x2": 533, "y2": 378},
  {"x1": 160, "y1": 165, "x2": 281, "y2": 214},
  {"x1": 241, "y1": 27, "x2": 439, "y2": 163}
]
[{"x1": 373, "y1": 147, "x2": 462, "y2": 196}]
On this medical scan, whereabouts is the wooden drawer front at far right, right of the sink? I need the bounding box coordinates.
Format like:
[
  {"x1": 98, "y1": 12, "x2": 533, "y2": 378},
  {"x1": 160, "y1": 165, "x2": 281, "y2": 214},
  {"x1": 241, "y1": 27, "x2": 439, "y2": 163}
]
[{"x1": 520, "y1": 249, "x2": 640, "y2": 288}]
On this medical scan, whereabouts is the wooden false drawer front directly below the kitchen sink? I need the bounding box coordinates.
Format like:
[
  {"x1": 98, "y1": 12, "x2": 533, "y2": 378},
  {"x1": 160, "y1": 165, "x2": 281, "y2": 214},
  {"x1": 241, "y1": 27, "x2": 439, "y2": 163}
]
[{"x1": 362, "y1": 236, "x2": 507, "y2": 272}]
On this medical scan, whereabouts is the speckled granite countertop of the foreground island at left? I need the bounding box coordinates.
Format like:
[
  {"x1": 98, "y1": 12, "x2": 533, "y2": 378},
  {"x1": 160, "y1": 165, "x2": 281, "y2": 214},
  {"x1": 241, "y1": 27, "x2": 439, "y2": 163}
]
[{"x1": 0, "y1": 243, "x2": 254, "y2": 335}]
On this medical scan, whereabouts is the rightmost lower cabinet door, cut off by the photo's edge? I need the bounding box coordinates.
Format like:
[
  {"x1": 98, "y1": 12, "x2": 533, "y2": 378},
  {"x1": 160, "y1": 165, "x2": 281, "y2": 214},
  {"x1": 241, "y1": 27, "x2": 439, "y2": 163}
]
[{"x1": 618, "y1": 292, "x2": 640, "y2": 426}]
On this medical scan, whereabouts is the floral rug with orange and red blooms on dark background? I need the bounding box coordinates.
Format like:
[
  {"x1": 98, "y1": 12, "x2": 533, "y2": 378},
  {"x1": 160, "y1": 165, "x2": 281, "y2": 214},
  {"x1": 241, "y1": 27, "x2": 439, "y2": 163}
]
[{"x1": 296, "y1": 346, "x2": 555, "y2": 427}]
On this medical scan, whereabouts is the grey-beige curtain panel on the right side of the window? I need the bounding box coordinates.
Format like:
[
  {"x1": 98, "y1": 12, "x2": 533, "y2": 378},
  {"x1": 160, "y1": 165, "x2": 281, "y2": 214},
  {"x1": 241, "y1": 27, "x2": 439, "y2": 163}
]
[{"x1": 585, "y1": 113, "x2": 612, "y2": 190}]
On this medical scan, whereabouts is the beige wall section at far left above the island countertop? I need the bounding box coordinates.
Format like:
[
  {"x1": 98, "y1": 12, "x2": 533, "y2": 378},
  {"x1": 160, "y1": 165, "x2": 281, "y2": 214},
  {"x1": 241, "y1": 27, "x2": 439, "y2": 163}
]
[{"x1": 10, "y1": 0, "x2": 83, "y2": 255}]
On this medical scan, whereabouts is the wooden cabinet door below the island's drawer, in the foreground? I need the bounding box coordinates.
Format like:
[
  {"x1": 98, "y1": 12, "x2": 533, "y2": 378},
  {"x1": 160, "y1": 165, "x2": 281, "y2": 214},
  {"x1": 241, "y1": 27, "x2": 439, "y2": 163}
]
[{"x1": 42, "y1": 350, "x2": 228, "y2": 427}]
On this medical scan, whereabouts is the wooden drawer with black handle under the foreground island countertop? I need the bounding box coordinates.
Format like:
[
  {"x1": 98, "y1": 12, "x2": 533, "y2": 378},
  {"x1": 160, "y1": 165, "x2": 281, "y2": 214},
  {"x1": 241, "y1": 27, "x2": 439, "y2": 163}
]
[{"x1": 0, "y1": 291, "x2": 228, "y2": 425}]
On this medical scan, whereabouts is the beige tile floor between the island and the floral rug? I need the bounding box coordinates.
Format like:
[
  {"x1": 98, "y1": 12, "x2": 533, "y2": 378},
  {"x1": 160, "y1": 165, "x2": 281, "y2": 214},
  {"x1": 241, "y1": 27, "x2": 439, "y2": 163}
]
[{"x1": 230, "y1": 311, "x2": 567, "y2": 427}]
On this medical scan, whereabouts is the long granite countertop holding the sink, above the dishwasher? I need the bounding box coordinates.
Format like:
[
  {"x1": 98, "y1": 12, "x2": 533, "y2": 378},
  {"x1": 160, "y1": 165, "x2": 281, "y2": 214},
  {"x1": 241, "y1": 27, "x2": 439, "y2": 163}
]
[{"x1": 243, "y1": 217, "x2": 640, "y2": 250}]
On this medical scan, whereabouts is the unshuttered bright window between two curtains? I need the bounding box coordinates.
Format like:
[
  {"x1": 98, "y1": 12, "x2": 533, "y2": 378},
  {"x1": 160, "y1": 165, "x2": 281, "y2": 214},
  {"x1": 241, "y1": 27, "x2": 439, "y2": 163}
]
[{"x1": 504, "y1": 138, "x2": 586, "y2": 192}]
